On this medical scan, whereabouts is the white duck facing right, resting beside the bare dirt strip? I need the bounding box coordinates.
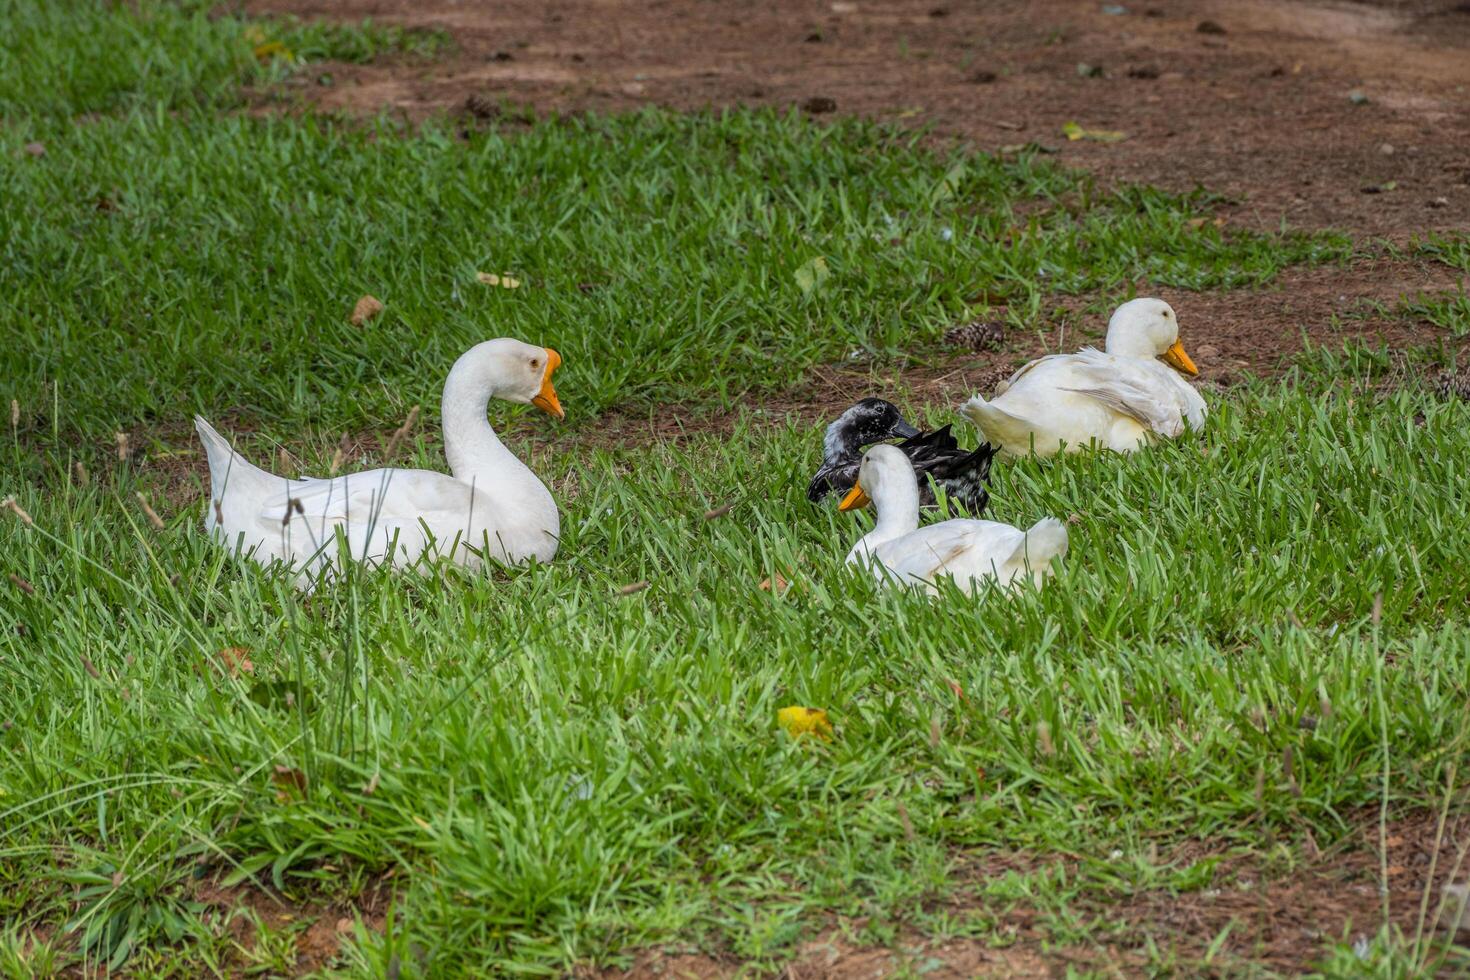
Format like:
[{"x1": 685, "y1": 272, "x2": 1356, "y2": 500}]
[{"x1": 960, "y1": 300, "x2": 1205, "y2": 455}]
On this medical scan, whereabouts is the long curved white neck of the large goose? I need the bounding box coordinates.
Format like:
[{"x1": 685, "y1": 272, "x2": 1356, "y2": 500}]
[{"x1": 440, "y1": 358, "x2": 554, "y2": 508}]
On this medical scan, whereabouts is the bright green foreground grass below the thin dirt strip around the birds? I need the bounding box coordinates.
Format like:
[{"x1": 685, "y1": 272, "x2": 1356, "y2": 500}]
[{"x1": 0, "y1": 379, "x2": 1470, "y2": 973}]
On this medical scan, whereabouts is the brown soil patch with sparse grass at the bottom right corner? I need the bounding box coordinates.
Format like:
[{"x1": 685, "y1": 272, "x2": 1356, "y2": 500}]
[{"x1": 588, "y1": 808, "x2": 1470, "y2": 980}]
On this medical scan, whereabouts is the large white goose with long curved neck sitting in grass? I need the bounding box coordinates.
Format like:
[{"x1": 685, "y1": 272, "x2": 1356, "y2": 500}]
[{"x1": 194, "y1": 338, "x2": 566, "y2": 588}]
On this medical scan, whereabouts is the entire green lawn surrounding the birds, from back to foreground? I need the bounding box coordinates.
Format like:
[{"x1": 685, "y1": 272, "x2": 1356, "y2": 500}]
[{"x1": 0, "y1": 0, "x2": 1470, "y2": 976}]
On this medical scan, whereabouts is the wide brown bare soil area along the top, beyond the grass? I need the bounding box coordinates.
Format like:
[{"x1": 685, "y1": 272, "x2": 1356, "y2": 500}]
[{"x1": 245, "y1": 0, "x2": 1470, "y2": 237}]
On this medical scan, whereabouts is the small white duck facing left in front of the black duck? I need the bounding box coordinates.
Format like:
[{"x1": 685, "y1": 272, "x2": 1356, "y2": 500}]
[{"x1": 838, "y1": 444, "x2": 1067, "y2": 595}]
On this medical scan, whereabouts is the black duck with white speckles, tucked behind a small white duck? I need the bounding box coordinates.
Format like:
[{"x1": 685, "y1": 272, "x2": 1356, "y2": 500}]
[{"x1": 807, "y1": 398, "x2": 995, "y2": 516}]
